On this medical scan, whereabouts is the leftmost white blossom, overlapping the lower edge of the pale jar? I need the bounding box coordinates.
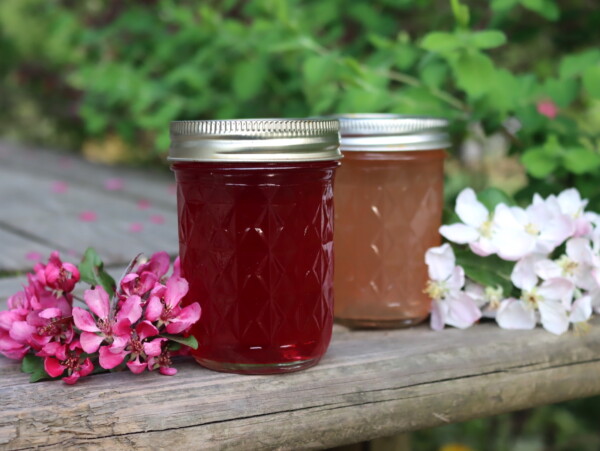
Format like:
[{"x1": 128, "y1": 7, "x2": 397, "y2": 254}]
[{"x1": 425, "y1": 244, "x2": 481, "y2": 330}]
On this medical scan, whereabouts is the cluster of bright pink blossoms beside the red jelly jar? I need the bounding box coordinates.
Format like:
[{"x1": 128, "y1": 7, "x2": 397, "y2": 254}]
[{"x1": 0, "y1": 252, "x2": 201, "y2": 384}]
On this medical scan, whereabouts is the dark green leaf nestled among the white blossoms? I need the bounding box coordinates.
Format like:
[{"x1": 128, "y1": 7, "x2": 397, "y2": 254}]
[{"x1": 454, "y1": 248, "x2": 515, "y2": 296}]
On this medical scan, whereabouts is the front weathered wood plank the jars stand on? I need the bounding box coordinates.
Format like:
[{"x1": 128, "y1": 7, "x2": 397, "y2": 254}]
[{"x1": 0, "y1": 321, "x2": 600, "y2": 449}]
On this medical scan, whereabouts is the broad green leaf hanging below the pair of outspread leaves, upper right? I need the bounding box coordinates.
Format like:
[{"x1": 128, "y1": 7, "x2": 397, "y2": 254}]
[{"x1": 450, "y1": 52, "x2": 496, "y2": 98}]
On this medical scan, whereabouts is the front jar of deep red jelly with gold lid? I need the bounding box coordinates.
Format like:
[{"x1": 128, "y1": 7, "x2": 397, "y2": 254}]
[{"x1": 169, "y1": 119, "x2": 341, "y2": 374}]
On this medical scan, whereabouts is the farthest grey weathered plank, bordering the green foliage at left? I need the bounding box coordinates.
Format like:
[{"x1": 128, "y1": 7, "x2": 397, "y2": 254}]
[{"x1": 0, "y1": 141, "x2": 175, "y2": 209}]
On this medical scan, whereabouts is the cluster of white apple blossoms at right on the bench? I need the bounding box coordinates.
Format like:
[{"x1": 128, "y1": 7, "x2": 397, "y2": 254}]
[{"x1": 425, "y1": 188, "x2": 600, "y2": 335}]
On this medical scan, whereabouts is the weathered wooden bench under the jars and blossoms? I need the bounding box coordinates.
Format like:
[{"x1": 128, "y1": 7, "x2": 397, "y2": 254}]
[{"x1": 0, "y1": 143, "x2": 600, "y2": 450}]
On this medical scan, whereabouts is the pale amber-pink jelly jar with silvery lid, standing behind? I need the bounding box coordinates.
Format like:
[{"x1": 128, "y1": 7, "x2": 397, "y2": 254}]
[{"x1": 335, "y1": 114, "x2": 449, "y2": 328}]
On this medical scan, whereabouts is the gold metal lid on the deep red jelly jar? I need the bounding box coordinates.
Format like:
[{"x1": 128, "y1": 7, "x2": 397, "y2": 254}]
[{"x1": 168, "y1": 119, "x2": 342, "y2": 163}]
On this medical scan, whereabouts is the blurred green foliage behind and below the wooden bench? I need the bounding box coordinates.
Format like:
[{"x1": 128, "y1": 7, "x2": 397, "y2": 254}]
[{"x1": 0, "y1": 0, "x2": 600, "y2": 449}]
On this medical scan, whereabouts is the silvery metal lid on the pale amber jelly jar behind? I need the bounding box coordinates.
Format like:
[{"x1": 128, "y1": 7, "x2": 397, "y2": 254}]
[{"x1": 331, "y1": 114, "x2": 450, "y2": 152}]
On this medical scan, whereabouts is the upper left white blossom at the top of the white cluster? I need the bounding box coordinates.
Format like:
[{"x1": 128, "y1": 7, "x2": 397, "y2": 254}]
[{"x1": 440, "y1": 188, "x2": 496, "y2": 257}]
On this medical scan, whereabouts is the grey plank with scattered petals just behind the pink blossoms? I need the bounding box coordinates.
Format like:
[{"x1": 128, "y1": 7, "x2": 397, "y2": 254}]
[{"x1": 0, "y1": 166, "x2": 178, "y2": 270}]
